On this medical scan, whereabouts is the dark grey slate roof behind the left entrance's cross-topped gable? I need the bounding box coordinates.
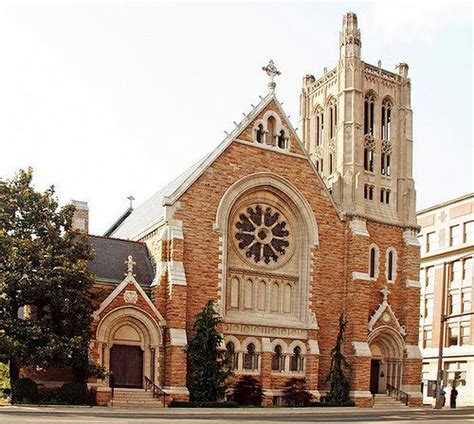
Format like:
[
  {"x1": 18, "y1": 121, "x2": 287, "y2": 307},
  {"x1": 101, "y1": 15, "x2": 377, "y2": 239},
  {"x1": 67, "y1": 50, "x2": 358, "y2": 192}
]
[{"x1": 89, "y1": 236, "x2": 154, "y2": 286}]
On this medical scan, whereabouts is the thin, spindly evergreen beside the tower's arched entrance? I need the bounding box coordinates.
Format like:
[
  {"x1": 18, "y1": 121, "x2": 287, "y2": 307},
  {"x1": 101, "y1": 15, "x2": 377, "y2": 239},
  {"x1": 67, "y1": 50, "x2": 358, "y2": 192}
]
[{"x1": 326, "y1": 314, "x2": 350, "y2": 404}]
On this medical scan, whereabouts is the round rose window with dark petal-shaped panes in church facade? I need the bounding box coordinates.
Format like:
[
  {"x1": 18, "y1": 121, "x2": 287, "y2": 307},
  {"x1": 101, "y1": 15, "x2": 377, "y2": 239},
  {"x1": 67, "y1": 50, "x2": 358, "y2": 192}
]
[{"x1": 235, "y1": 205, "x2": 290, "y2": 264}]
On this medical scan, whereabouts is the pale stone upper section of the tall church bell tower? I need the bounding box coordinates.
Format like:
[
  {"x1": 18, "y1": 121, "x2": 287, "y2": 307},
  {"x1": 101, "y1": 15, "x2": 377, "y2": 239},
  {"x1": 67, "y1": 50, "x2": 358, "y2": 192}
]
[{"x1": 300, "y1": 12, "x2": 416, "y2": 226}]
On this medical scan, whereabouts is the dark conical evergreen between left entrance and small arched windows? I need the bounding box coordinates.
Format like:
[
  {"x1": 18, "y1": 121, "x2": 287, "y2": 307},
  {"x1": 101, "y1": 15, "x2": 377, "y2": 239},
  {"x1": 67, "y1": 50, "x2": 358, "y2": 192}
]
[{"x1": 188, "y1": 301, "x2": 231, "y2": 402}]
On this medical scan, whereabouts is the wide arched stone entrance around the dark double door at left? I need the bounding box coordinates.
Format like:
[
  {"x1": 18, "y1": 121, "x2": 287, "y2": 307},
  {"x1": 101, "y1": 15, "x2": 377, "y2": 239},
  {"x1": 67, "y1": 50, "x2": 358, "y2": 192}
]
[{"x1": 96, "y1": 306, "x2": 161, "y2": 388}]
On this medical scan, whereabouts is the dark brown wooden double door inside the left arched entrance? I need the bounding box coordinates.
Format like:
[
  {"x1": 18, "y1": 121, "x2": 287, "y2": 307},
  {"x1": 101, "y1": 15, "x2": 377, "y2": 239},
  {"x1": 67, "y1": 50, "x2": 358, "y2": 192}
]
[{"x1": 110, "y1": 345, "x2": 143, "y2": 388}]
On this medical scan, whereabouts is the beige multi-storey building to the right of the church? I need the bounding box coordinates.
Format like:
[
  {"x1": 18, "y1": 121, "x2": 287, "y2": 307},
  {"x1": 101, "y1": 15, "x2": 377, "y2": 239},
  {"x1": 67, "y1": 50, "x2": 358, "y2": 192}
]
[{"x1": 417, "y1": 193, "x2": 474, "y2": 406}]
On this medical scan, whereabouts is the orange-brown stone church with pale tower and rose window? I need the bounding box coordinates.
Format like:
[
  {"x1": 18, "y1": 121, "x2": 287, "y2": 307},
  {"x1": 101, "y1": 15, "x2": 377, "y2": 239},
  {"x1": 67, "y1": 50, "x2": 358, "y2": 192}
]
[{"x1": 64, "y1": 13, "x2": 422, "y2": 407}]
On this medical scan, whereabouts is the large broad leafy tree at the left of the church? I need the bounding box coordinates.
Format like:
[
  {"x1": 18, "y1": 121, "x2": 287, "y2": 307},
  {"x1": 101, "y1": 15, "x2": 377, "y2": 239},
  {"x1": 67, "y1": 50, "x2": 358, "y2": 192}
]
[{"x1": 0, "y1": 168, "x2": 98, "y2": 387}]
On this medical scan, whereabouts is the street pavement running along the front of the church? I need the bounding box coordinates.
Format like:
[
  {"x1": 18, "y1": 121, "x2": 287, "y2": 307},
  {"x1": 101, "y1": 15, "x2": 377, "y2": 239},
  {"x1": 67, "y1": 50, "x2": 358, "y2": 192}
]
[{"x1": 0, "y1": 406, "x2": 474, "y2": 424}]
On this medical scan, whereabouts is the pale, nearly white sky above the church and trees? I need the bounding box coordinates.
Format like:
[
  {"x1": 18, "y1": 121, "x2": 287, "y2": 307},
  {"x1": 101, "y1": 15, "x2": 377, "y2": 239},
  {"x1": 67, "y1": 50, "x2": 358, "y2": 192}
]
[{"x1": 0, "y1": 1, "x2": 474, "y2": 234}]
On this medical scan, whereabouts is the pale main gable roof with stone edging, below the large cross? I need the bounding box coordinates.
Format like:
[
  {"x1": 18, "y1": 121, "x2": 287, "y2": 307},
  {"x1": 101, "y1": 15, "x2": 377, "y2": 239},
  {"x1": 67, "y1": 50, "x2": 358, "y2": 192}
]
[{"x1": 110, "y1": 91, "x2": 339, "y2": 239}]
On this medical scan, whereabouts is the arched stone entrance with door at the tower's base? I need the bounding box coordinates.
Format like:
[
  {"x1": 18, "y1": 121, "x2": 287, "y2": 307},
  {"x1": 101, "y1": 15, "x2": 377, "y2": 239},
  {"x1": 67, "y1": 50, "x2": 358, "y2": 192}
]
[{"x1": 369, "y1": 327, "x2": 404, "y2": 394}]
